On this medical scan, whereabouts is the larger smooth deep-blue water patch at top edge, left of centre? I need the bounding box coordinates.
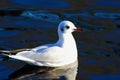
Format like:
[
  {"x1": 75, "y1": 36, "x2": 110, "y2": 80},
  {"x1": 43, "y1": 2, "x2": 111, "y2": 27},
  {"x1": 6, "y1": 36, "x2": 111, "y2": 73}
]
[{"x1": 9, "y1": 0, "x2": 69, "y2": 8}]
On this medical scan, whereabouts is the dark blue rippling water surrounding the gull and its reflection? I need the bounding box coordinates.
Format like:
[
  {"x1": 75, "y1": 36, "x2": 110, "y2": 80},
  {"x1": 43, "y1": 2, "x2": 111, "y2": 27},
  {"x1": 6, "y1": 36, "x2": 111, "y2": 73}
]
[{"x1": 0, "y1": 0, "x2": 120, "y2": 80}]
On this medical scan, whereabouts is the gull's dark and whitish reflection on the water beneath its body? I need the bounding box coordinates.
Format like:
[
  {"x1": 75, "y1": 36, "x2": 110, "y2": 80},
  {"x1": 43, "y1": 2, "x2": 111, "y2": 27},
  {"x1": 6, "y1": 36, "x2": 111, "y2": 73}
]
[{"x1": 9, "y1": 61, "x2": 78, "y2": 80}]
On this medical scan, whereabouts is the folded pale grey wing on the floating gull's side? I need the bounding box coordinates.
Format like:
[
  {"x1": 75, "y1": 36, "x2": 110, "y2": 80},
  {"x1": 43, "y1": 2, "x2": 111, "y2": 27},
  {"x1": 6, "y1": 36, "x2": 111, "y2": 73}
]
[{"x1": 17, "y1": 45, "x2": 64, "y2": 63}]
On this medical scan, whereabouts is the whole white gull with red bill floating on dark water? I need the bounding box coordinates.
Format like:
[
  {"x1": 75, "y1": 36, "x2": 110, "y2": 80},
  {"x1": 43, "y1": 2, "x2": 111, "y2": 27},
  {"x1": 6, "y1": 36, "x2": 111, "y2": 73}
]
[{"x1": 0, "y1": 20, "x2": 82, "y2": 67}]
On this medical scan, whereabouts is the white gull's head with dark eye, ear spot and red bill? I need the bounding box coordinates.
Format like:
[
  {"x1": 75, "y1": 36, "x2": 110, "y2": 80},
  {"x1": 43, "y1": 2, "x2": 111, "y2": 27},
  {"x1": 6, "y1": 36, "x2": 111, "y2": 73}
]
[{"x1": 58, "y1": 20, "x2": 82, "y2": 33}]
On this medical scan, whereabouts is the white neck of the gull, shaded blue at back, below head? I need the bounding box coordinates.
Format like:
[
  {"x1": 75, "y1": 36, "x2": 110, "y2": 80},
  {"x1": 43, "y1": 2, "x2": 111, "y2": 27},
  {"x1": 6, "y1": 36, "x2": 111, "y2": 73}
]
[{"x1": 56, "y1": 34, "x2": 76, "y2": 47}]
